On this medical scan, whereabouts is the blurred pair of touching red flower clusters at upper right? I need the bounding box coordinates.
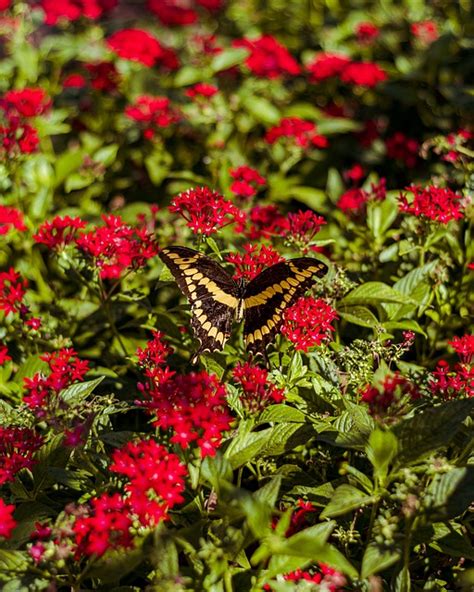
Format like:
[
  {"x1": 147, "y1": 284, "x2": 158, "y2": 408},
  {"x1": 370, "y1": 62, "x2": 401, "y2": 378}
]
[{"x1": 307, "y1": 53, "x2": 387, "y2": 88}]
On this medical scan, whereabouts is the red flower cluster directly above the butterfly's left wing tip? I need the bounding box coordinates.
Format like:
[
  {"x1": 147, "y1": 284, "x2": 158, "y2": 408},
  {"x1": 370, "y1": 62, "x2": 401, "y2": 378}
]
[{"x1": 169, "y1": 187, "x2": 245, "y2": 236}]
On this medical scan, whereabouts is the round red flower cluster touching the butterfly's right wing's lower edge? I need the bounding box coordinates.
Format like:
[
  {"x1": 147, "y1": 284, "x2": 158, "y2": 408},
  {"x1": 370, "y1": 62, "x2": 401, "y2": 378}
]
[{"x1": 281, "y1": 296, "x2": 338, "y2": 352}]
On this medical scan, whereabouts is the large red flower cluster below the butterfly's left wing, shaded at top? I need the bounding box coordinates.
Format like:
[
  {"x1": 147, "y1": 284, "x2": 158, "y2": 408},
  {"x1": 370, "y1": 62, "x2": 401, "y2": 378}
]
[{"x1": 138, "y1": 371, "x2": 232, "y2": 458}]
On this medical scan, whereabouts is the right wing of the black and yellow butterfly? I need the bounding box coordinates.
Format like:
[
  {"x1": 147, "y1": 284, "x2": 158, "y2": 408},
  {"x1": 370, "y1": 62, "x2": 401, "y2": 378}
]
[{"x1": 244, "y1": 257, "x2": 328, "y2": 355}]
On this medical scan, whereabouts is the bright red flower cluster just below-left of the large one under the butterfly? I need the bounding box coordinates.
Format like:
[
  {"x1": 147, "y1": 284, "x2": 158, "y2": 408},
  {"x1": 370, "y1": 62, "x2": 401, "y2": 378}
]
[{"x1": 110, "y1": 439, "x2": 187, "y2": 526}]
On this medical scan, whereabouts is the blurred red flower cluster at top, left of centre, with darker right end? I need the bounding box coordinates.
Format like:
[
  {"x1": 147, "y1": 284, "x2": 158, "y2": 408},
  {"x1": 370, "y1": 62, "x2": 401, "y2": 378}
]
[{"x1": 107, "y1": 29, "x2": 179, "y2": 70}]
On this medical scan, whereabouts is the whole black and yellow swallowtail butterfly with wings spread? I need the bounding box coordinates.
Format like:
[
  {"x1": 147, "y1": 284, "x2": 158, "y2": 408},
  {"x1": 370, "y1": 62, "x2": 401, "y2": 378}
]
[{"x1": 160, "y1": 247, "x2": 328, "y2": 363}]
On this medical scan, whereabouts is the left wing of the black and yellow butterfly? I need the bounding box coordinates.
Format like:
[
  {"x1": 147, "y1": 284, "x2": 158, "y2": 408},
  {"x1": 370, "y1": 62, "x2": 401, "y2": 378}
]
[{"x1": 160, "y1": 247, "x2": 239, "y2": 359}]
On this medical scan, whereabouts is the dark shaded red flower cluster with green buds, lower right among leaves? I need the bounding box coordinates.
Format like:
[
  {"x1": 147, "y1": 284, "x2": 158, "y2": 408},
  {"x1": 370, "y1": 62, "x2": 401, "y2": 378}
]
[{"x1": 361, "y1": 372, "x2": 420, "y2": 416}]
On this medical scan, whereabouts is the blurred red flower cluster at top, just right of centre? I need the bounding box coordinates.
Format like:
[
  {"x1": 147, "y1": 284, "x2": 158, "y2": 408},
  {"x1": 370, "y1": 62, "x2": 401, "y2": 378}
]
[{"x1": 232, "y1": 35, "x2": 301, "y2": 80}]
